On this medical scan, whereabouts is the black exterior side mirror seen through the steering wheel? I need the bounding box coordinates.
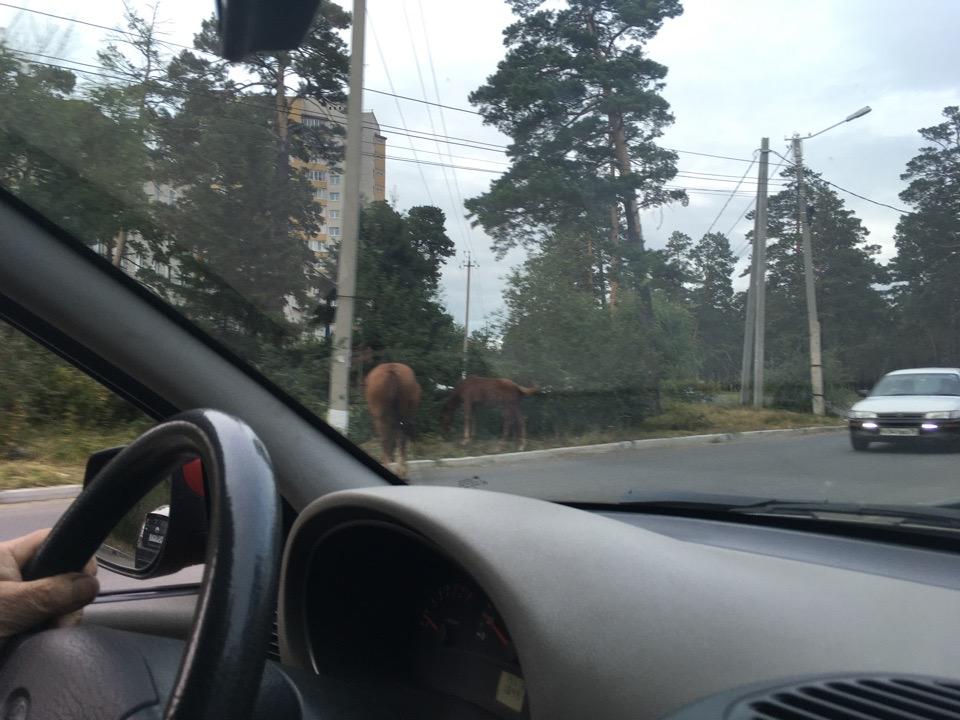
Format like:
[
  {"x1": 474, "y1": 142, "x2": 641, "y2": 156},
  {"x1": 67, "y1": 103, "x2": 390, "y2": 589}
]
[{"x1": 83, "y1": 447, "x2": 207, "y2": 578}]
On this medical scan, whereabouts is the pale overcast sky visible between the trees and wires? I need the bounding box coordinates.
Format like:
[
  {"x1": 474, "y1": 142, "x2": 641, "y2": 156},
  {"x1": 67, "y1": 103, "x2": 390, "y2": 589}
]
[{"x1": 0, "y1": 0, "x2": 960, "y2": 328}]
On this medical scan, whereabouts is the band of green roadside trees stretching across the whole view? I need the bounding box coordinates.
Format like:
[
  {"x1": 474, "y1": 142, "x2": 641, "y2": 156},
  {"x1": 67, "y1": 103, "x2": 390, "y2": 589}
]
[{"x1": 0, "y1": 0, "x2": 960, "y2": 448}]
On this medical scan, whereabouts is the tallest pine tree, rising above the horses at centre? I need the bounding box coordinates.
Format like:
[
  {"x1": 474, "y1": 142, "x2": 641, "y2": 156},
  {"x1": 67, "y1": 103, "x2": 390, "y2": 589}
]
[{"x1": 467, "y1": 0, "x2": 685, "y2": 313}]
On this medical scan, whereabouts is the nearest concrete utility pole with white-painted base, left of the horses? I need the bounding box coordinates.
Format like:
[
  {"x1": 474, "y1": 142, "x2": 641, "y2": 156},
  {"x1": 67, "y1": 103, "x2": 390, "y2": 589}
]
[{"x1": 327, "y1": 0, "x2": 366, "y2": 434}]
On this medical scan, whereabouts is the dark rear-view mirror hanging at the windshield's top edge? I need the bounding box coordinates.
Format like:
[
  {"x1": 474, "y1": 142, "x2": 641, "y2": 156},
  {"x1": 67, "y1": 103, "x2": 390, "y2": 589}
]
[{"x1": 217, "y1": 0, "x2": 320, "y2": 62}]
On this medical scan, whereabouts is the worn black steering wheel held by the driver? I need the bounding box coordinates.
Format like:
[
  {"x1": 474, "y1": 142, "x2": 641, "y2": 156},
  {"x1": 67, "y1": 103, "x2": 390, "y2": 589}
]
[{"x1": 0, "y1": 410, "x2": 280, "y2": 720}]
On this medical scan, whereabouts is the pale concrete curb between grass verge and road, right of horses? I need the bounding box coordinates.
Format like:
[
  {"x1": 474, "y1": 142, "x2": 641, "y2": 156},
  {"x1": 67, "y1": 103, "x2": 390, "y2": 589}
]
[{"x1": 407, "y1": 425, "x2": 846, "y2": 469}]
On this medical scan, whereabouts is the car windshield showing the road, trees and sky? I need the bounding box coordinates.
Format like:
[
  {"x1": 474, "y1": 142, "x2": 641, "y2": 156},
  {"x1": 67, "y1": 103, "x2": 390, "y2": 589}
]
[{"x1": 0, "y1": 0, "x2": 960, "y2": 505}]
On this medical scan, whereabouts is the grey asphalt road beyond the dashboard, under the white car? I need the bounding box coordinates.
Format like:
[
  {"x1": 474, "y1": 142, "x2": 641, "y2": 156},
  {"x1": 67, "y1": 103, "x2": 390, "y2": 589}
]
[{"x1": 0, "y1": 432, "x2": 960, "y2": 591}]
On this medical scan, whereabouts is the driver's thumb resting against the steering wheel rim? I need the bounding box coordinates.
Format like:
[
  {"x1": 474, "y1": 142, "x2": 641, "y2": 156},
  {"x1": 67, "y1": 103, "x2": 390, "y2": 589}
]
[{"x1": 0, "y1": 573, "x2": 100, "y2": 637}]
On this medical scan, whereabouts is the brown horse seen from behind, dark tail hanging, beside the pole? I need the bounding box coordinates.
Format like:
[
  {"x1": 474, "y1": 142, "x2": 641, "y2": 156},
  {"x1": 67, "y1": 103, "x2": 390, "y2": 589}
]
[{"x1": 366, "y1": 363, "x2": 421, "y2": 477}]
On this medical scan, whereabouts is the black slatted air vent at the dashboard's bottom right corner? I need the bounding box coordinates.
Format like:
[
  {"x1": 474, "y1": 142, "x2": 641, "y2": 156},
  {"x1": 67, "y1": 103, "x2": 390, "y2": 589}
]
[{"x1": 727, "y1": 676, "x2": 960, "y2": 720}]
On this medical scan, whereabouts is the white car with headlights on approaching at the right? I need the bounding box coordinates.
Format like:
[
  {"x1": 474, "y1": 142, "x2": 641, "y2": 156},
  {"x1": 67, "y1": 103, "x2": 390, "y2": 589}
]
[{"x1": 847, "y1": 368, "x2": 960, "y2": 450}]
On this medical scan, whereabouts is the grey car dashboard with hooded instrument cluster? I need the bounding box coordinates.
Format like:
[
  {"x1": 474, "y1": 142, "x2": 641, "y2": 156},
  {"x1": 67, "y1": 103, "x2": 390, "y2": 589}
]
[{"x1": 87, "y1": 487, "x2": 960, "y2": 720}]
